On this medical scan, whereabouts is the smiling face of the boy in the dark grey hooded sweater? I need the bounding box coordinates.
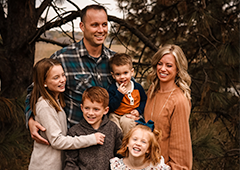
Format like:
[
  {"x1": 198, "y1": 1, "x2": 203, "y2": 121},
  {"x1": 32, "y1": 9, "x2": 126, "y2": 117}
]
[{"x1": 81, "y1": 98, "x2": 109, "y2": 129}]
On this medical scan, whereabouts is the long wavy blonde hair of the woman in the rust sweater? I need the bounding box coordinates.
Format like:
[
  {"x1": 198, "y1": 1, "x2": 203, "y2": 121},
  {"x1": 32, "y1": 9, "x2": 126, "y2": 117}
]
[{"x1": 149, "y1": 44, "x2": 191, "y2": 100}]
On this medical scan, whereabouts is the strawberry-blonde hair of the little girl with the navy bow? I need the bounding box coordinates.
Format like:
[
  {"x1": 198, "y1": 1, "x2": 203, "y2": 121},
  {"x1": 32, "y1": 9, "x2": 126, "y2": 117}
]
[{"x1": 117, "y1": 124, "x2": 162, "y2": 165}]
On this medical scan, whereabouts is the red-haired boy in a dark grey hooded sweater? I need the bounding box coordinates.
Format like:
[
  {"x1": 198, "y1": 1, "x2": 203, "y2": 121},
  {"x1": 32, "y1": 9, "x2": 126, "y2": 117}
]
[{"x1": 65, "y1": 86, "x2": 122, "y2": 170}]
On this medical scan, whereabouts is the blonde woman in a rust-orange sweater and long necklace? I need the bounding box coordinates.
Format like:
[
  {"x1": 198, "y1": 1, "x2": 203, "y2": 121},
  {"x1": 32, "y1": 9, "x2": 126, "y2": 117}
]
[{"x1": 144, "y1": 45, "x2": 192, "y2": 170}]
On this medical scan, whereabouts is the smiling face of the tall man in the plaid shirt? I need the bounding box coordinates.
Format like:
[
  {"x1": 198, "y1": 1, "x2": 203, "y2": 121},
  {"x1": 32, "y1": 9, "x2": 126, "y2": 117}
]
[{"x1": 80, "y1": 9, "x2": 108, "y2": 47}]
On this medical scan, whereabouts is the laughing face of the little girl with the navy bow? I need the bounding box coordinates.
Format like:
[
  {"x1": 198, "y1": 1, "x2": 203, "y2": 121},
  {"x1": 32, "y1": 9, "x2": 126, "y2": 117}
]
[{"x1": 127, "y1": 129, "x2": 150, "y2": 160}]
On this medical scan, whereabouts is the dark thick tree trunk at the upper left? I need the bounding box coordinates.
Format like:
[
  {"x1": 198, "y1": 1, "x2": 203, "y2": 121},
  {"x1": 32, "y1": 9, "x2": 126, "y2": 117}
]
[{"x1": 0, "y1": 0, "x2": 37, "y2": 98}]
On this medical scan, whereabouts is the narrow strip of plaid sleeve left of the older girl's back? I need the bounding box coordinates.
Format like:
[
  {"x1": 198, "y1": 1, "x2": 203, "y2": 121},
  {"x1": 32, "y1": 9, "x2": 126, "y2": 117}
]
[{"x1": 24, "y1": 83, "x2": 34, "y2": 128}]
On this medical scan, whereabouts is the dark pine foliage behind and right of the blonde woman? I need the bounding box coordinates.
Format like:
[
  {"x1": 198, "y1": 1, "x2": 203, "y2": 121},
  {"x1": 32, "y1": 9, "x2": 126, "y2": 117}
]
[{"x1": 111, "y1": 0, "x2": 240, "y2": 169}]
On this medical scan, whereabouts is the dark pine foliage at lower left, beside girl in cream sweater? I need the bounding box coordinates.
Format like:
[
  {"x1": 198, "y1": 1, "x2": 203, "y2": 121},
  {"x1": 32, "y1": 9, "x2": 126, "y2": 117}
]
[{"x1": 0, "y1": 95, "x2": 32, "y2": 170}]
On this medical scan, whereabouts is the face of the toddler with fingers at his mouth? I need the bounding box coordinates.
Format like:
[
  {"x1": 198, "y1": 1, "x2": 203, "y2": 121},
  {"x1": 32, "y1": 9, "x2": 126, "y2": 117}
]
[{"x1": 111, "y1": 64, "x2": 134, "y2": 87}]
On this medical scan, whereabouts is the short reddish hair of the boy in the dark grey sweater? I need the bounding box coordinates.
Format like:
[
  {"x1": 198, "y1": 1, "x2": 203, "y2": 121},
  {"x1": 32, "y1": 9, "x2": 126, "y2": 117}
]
[{"x1": 82, "y1": 86, "x2": 109, "y2": 108}]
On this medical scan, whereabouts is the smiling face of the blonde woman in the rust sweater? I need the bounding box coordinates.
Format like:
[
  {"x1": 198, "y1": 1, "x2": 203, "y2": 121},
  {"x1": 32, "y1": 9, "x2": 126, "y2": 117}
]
[{"x1": 157, "y1": 54, "x2": 178, "y2": 83}]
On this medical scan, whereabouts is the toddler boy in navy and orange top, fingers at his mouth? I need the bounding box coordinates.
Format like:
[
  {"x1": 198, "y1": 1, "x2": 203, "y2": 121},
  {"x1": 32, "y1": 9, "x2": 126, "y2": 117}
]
[{"x1": 108, "y1": 53, "x2": 147, "y2": 136}]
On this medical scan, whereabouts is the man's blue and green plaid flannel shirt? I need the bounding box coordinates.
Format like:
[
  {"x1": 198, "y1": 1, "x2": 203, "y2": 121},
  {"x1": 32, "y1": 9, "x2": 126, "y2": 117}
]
[{"x1": 25, "y1": 40, "x2": 115, "y2": 127}]
